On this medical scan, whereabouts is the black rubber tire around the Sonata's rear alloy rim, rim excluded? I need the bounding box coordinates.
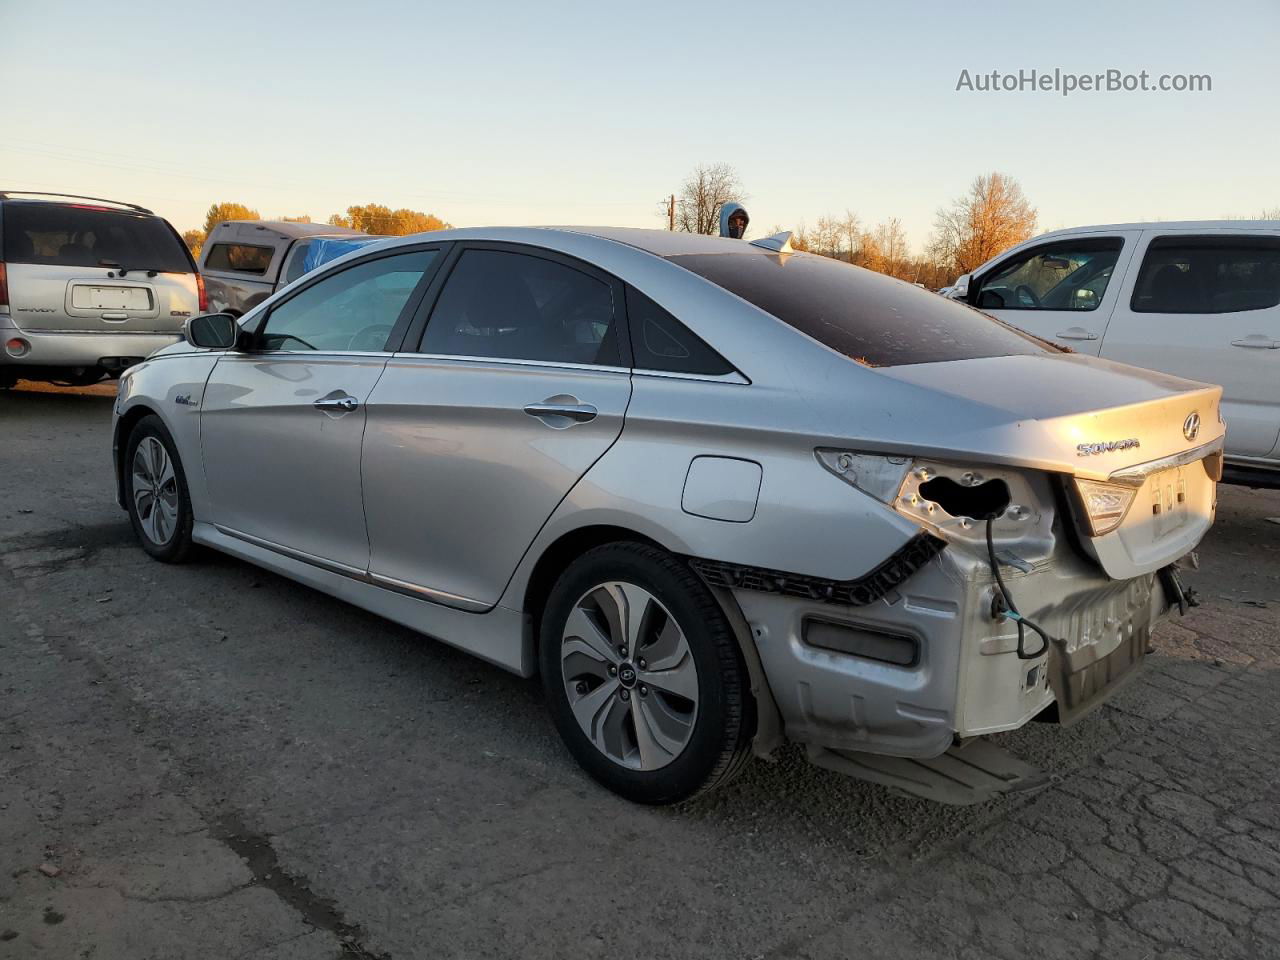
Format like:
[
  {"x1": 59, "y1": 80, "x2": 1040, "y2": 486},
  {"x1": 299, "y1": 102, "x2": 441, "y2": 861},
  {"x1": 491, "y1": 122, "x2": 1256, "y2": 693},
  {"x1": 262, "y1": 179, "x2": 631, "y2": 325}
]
[{"x1": 539, "y1": 543, "x2": 755, "y2": 804}]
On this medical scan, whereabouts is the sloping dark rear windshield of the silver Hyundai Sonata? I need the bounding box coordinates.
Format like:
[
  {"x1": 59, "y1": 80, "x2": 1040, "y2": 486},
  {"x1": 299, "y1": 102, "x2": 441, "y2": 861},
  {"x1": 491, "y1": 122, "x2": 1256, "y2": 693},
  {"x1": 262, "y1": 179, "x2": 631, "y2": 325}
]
[{"x1": 669, "y1": 251, "x2": 1059, "y2": 366}]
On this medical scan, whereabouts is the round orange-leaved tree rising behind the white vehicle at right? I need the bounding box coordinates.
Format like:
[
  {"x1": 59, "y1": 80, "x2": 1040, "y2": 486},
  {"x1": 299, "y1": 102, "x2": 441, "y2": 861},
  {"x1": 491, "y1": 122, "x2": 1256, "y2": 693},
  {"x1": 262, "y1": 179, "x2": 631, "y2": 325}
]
[{"x1": 929, "y1": 173, "x2": 1036, "y2": 274}]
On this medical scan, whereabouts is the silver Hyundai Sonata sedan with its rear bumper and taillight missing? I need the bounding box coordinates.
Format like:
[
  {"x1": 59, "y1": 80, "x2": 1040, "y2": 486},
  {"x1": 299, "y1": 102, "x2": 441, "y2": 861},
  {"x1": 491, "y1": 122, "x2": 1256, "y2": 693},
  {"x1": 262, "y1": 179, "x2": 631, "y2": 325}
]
[{"x1": 114, "y1": 228, "x2": 1222, "y2": 804}]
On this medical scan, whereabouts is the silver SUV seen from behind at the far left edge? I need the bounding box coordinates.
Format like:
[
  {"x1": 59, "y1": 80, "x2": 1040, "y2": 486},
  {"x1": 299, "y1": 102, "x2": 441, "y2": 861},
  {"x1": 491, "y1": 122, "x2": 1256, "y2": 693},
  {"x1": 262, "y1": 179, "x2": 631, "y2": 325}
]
[{"x1": 0, "y1": 191, "x2": 199, "y2": 387}]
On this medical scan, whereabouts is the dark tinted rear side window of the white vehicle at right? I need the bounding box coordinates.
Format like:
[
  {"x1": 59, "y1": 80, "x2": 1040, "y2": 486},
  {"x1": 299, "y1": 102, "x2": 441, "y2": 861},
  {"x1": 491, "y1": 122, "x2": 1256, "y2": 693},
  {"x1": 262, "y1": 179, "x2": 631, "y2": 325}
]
[{"x1": 1132, "y1": 237, "x2": 1280, "y2": 314}]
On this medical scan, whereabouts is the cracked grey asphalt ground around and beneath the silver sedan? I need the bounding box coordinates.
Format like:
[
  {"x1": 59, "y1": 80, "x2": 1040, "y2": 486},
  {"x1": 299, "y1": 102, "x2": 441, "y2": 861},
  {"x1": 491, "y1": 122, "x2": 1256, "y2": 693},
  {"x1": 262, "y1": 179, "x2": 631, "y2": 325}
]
[{"x1": 0, "y1": 387, "x2": 1280, "y2": 960}]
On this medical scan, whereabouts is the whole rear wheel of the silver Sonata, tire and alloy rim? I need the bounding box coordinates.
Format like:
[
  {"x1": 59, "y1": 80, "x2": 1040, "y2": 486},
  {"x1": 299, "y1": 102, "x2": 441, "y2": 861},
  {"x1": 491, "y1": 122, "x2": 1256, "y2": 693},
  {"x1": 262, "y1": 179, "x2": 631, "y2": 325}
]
[{"x1": 540, "y1": 543, "x2": 754, "y2": 804}]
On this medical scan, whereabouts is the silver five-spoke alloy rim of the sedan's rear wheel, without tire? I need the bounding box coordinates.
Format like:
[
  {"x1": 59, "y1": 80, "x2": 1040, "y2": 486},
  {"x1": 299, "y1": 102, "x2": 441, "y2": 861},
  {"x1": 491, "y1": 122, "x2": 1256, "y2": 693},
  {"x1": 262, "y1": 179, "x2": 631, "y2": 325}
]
[{"x1": 561, "y1": 581, "x2": 698, "y2": 771}]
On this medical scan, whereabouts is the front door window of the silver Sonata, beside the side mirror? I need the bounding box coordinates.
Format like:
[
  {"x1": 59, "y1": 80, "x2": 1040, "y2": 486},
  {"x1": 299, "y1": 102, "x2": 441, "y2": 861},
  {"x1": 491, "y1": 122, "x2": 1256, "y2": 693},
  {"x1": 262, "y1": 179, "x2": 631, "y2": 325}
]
[{"x1": 261, "y1": 250, "x2": 435, "y2": 351}]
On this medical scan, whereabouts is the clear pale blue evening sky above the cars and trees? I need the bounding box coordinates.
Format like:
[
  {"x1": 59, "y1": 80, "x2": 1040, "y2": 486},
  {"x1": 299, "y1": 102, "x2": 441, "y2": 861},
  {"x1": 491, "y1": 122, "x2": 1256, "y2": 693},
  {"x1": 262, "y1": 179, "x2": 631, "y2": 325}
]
[{"x1": 0, "y1": 0, "x2": 1280, "y2": 256}]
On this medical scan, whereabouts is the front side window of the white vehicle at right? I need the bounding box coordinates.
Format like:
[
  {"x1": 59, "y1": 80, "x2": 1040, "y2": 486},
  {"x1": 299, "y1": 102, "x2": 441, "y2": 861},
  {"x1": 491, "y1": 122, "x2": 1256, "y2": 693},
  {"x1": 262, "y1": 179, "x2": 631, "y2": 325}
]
[{"x1": 974, "y1": 237, "x2": 1124, "y2": 310}]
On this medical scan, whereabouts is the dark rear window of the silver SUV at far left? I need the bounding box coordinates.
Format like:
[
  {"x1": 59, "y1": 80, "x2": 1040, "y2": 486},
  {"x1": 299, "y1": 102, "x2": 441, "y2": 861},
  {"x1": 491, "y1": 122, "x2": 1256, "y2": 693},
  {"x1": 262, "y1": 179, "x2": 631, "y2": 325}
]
[{"x1": 0, "y1": 204, "x2": 195, "y2": 274}]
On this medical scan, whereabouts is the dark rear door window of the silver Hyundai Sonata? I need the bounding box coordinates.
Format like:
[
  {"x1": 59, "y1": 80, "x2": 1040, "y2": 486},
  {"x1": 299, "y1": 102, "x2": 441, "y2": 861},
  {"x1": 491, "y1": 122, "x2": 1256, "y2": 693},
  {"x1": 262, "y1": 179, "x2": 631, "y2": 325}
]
[{"x1": 422, "y1": 250, "x2": 621, "y2": 366}]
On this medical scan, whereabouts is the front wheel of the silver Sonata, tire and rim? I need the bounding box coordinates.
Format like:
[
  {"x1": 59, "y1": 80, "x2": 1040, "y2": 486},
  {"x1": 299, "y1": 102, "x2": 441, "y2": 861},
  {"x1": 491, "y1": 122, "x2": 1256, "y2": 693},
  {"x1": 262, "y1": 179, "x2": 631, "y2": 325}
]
[{"x1": 124, "y1": 415, "x2": 192, "y2": 563}]
